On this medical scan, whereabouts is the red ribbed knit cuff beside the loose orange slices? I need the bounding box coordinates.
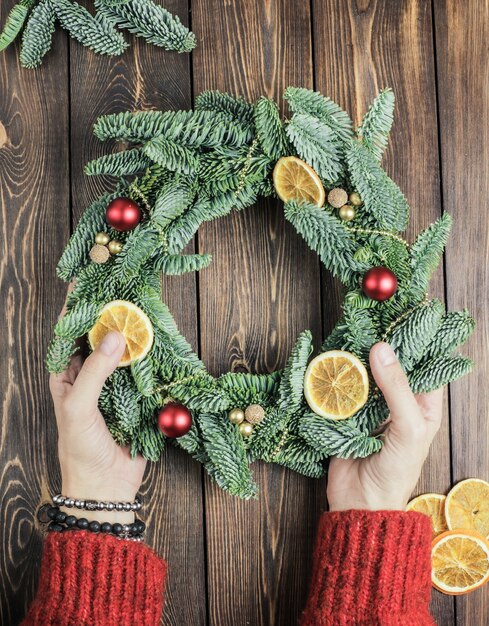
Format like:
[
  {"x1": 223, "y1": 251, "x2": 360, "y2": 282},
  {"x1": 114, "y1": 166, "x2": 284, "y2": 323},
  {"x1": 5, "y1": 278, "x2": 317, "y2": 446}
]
[{"x1": 300, "y1": 510, "x2": 435, "y2": 626}]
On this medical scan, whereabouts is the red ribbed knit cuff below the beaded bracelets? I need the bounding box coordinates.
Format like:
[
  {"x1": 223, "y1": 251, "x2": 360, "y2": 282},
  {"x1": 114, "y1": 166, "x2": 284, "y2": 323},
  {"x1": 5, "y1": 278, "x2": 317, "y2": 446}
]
[{"x1": 22, "y1": 531, "x2": 166, "y2": 626}]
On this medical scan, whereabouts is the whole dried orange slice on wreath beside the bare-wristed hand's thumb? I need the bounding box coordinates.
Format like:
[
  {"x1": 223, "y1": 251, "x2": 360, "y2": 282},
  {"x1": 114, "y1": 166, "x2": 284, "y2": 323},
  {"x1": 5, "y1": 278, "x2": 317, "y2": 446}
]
[{"x1": 304, "y1": 350, "x2": 368, "y2": 420}]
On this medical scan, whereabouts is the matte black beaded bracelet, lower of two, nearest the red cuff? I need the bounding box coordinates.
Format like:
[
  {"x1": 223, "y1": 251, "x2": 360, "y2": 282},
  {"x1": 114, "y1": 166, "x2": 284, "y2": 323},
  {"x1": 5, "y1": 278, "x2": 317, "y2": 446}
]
[{"x1": 37, "y1": 504, "x2": 146, "y2": 541}]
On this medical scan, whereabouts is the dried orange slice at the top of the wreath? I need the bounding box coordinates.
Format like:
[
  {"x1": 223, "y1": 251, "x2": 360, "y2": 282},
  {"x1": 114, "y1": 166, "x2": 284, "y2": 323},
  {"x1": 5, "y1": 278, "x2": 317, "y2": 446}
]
[{"x1": 273, "y1": 156, "x2": 326, "y2": 207}]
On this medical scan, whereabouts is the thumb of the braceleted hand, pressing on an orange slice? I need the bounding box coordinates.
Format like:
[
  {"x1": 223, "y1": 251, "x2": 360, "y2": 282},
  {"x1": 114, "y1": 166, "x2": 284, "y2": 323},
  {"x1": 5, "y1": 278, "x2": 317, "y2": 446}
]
[{"x1": 71, "y1": 332, "x2": 126, "y2": 407}]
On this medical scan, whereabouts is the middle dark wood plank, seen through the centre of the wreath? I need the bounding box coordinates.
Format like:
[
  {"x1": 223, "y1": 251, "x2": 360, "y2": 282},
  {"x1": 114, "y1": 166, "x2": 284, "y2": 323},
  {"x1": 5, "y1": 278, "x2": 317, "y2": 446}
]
[{"x1": 192, "y1": 0, "x2": 325, "y2": 626}]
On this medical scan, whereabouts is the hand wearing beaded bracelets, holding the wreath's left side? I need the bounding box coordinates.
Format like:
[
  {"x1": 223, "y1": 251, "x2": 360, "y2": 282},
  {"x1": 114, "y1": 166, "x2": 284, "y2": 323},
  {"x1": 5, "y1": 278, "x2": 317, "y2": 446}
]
[{"x1": 49, "y1": 288, "x2": 146, "y2": 523}]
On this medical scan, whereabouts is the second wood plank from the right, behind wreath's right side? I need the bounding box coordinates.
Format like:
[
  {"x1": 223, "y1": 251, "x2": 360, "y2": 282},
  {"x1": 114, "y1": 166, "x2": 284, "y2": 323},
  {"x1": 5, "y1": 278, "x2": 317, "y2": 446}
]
[{"x1": 314, "y1": 0, "x2": 454, "y2": 625}]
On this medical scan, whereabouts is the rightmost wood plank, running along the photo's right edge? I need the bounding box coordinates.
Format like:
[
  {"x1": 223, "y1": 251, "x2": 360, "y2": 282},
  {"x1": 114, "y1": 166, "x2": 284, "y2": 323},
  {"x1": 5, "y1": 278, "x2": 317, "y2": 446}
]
[{"x1": 434, "y1": 0, "x2": 489, "y2": 626}]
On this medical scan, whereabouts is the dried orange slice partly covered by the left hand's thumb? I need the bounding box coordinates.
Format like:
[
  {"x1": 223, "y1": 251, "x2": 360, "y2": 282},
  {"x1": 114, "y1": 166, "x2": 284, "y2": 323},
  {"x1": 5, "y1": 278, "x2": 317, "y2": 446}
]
[{"x1": 88, "y1": 300, "x2": 153, "y2": 367}]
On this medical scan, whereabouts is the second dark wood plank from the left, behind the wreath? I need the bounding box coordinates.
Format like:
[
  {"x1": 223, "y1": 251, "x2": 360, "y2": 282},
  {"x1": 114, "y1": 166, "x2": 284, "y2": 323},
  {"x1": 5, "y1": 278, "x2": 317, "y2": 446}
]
[{"x1": 67, "y1": 0, "x2": 206, "y2": 625}]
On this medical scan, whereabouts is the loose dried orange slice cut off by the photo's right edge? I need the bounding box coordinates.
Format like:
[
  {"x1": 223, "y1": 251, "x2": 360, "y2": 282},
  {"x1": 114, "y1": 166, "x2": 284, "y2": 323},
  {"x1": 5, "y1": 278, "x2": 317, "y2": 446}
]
[{"x1": 445, "y1": 478, "x2": 489, "y2": 539}]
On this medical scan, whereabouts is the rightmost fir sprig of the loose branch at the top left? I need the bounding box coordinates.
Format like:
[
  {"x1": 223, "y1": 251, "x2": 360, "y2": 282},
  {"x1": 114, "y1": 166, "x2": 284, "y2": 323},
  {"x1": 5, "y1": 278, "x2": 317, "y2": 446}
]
[{"x1": 95, "y1": 0, "x2": 196, "y2": 52}]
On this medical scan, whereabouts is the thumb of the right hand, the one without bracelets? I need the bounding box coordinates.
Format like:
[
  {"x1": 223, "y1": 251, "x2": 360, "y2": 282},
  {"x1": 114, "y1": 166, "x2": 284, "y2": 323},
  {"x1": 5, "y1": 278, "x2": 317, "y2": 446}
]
[{"x1": 370, "y1": 342, "x2": 424, "y2": 446}]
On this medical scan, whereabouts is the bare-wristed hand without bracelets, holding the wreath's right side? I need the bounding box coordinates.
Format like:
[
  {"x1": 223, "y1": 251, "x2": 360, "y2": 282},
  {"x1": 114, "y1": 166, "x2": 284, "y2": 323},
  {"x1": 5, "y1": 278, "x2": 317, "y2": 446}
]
[{"x1": 327, "y1": 343, "x2": 443, "y2": 511}]
